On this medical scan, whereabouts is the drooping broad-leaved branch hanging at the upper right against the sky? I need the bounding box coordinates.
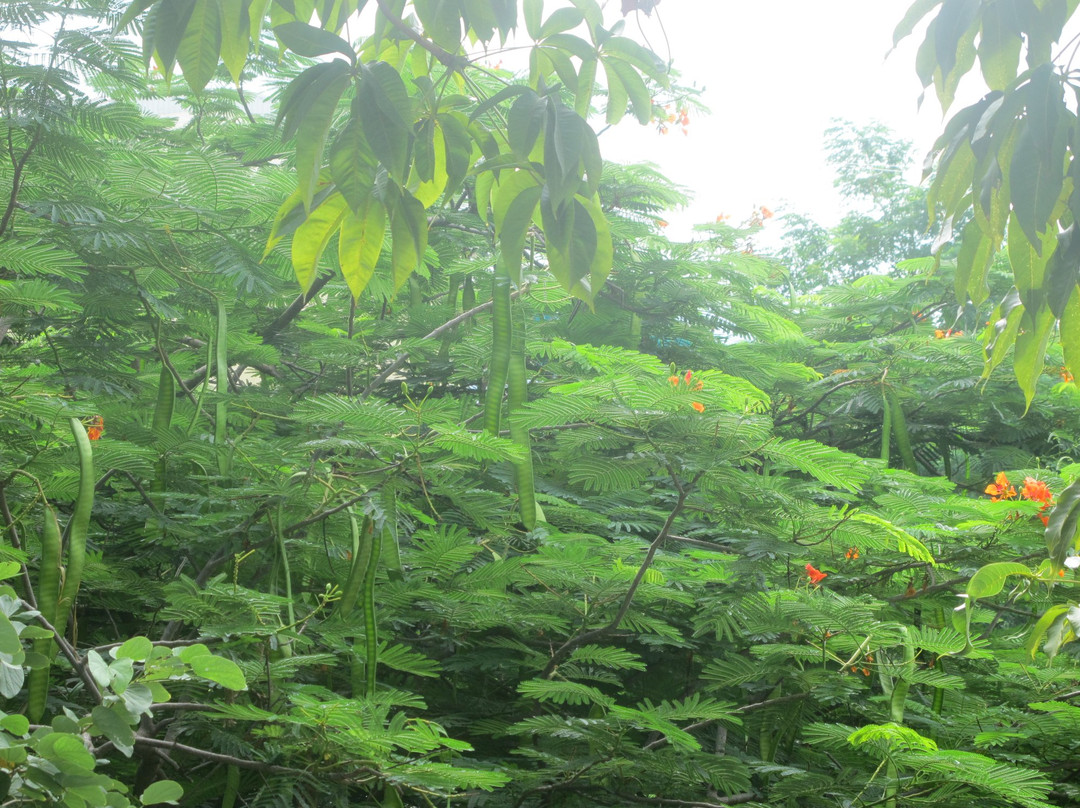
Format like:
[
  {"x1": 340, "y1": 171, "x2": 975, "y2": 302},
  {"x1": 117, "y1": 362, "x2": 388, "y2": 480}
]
[{"x1": 895, "y1": 0, "x2": 1080, "y2": 403}]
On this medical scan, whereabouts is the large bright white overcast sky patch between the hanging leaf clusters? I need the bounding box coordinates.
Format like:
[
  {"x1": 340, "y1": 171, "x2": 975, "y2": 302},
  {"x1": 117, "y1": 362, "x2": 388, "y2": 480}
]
[{"x1": 600, "y1": 0, "x2": 985, "y2": 238}]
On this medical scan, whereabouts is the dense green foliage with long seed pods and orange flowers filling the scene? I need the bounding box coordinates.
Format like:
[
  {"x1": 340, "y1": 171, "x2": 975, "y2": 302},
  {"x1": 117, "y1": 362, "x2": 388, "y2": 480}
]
[{"x1": 6, "y1": 0, "x2": 1080, "y2": 808}]
